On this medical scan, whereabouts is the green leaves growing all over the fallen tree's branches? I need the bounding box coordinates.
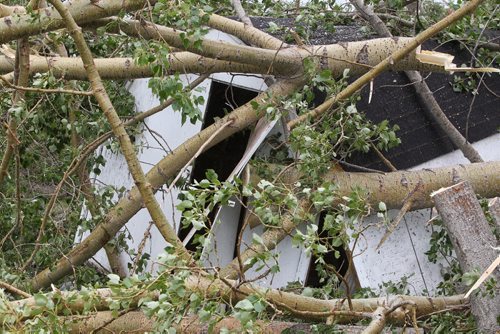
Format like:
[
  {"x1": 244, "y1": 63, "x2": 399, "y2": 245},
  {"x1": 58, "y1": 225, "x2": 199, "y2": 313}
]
[{"x1": 0, "y1": 0, "x2": 499, "y2": 333}]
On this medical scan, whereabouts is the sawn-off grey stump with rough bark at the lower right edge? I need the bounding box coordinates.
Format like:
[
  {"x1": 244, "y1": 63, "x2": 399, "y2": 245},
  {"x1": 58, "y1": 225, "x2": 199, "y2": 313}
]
[{"x1": 432, "y1": 182, "x2": 500, "y2": 333}]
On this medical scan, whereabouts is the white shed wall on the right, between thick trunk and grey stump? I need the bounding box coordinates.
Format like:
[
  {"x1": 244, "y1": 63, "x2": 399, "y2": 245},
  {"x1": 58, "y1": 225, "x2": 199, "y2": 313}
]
[{"x1": 351, "y1": 134, "x2": 500, "y2": 295}]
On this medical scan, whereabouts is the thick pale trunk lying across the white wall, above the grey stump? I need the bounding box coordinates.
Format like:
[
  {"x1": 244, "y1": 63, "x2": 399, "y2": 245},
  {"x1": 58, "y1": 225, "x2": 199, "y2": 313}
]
[{"x1": 223, "y1": 162, "x2": 500, "y2": 279}]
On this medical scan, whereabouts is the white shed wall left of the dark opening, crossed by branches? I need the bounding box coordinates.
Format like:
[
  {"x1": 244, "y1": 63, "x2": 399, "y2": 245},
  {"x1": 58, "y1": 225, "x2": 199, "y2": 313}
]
[{"x1": 77, "y1": 75, "x2": 211, "y2": 270}]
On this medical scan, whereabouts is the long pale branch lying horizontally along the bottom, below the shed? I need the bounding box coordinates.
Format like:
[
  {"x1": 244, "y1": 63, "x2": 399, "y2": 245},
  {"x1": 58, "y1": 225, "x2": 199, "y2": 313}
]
[{"x1": 0, "y1": 273, "x2": 466, "y2": 324}]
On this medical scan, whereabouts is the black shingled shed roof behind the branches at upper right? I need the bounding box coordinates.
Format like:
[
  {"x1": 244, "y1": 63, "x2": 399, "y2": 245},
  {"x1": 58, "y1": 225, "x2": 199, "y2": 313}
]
[{"x1": 245, "y1": 17, "x2": 500, "y2": 170}]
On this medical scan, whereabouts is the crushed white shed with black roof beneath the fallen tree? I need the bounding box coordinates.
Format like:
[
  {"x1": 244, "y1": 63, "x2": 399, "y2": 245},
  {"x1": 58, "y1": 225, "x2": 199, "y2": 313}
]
[{"x1": 77, "y1": 19, "x2": 500, "y2": 294}]
